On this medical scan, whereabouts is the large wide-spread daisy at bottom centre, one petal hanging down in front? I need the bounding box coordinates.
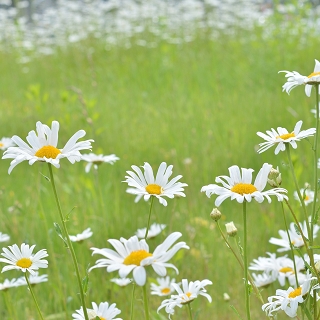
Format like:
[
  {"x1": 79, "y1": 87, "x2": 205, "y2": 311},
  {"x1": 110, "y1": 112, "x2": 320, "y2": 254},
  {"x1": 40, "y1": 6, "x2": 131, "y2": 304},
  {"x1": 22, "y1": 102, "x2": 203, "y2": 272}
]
[{"x1": 89, "y1": 232, "x2": 189, "y2": 286}]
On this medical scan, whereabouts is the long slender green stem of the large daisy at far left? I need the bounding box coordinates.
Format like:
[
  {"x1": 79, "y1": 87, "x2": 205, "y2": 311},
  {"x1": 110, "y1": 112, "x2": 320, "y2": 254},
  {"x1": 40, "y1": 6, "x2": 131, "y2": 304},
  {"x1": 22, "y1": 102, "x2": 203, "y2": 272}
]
[{"x1": 48, "y1": 163, "x2": 89, "y2": 320}]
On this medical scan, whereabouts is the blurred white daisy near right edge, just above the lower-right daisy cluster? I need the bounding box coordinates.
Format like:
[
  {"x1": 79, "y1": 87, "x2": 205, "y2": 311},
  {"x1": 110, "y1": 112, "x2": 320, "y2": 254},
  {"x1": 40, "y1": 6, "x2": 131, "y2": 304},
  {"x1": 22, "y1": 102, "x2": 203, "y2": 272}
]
[{"x1": 269, "y1": 221, "x2": 320, "y2": 252}]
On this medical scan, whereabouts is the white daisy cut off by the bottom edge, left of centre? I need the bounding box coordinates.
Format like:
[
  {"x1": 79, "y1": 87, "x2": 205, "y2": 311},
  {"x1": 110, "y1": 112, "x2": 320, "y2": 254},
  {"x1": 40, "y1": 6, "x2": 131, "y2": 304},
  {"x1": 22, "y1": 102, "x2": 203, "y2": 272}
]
[{"x1": 72, "y1": 302, "x2": 122, "y2": 320}]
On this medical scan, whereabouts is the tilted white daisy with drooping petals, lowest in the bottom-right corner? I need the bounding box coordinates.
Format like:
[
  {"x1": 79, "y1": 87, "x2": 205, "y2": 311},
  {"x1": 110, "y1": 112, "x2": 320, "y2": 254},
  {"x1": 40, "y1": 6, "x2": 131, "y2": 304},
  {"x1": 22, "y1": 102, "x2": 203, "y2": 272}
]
[{"x1": 262, "y1": 273, "x2": 318, "y2": 318}]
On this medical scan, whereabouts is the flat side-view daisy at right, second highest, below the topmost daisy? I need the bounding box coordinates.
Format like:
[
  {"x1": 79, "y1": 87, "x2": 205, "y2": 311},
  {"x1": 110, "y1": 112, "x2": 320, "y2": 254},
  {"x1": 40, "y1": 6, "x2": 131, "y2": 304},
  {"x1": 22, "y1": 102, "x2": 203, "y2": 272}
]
[{"x1": 257, "y1": 120, "x2": 316, "y2": 154}]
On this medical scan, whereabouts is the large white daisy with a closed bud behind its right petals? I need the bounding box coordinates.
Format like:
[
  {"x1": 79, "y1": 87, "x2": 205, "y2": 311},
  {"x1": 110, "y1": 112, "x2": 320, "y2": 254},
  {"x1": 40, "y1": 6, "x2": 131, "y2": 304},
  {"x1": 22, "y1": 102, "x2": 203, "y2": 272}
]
[{"x1": 201, "y1": 163, "x2": 288, "y2": 207}]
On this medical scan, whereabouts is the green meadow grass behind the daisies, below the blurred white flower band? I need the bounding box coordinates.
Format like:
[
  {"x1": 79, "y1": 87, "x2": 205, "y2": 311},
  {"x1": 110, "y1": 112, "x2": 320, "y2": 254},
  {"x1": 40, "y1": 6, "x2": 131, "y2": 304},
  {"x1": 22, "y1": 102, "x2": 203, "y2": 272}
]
[{"x1": 0, "y1": 25, "x2": 317, "y2": 320}]
